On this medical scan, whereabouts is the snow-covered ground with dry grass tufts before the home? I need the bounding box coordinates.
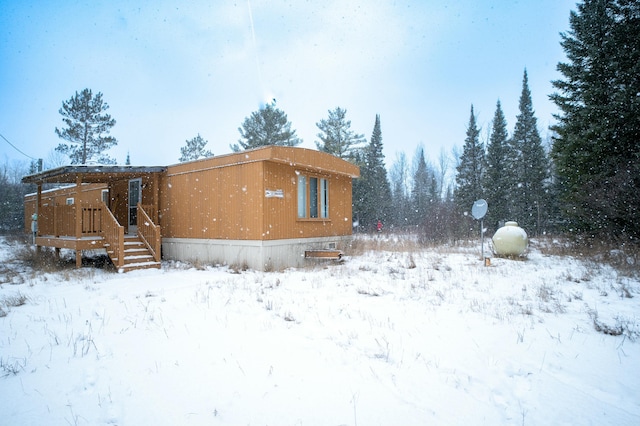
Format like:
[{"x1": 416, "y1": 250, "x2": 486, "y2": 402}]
[{"x1": 0, "y1": 235, "x2": 640, "y2": 425}]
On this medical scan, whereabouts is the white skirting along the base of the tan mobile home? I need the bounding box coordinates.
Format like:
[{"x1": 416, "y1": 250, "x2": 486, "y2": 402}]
[{"x1": 162, "y1": 236, "x2": 351, "y2": 271}]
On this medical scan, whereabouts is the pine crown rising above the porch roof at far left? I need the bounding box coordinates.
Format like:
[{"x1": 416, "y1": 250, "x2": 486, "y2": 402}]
[{"x1": 55, "y1": 89, "x2": 118, "y2": 164}]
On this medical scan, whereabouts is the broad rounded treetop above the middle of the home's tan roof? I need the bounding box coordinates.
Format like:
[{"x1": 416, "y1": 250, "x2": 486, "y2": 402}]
[{"x1": 231, "y1": 102, "x2": 302, "y2": 152}]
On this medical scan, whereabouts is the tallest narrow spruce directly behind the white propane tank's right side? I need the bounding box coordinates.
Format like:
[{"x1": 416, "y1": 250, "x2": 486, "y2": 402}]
[{"x1": 511, "y1": 70, "x2": 549, "y2": 235}]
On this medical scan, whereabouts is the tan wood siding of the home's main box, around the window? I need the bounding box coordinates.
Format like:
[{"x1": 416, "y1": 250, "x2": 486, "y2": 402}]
[{"x1": 160, "y1": 148, "x2": 358, "y2": 240}]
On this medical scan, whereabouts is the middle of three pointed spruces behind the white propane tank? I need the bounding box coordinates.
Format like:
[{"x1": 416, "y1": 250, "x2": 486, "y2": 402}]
[{"x1": 483, "y1": 101, "x2": 516, "y2": 229}]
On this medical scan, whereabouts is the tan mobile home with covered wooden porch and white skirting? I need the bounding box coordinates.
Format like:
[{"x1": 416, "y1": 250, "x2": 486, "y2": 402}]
[{"x1": 23, "y1": 146, "x2": 359, "y2": 270}]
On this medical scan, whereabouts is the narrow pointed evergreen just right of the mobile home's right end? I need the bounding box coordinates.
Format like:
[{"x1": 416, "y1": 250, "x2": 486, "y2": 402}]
[{"x1": 354, "y1": 115, "x2": 391, "y2": 229}]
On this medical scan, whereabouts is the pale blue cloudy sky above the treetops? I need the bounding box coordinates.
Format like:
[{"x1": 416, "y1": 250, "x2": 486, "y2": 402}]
[{"x1": 0, "y1": 0, "x2": 576, "y2": 171}]
